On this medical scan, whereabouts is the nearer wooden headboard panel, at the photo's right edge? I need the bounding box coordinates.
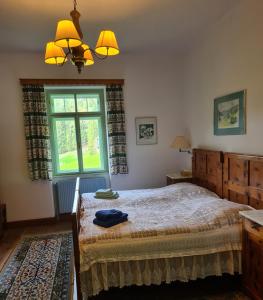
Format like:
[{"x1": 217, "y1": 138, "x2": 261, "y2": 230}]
[{"x1": 223, "y1": 153, "x2": 263, "y2": 209}]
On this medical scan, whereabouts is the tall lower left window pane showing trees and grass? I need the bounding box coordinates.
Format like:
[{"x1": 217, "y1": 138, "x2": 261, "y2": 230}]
[{"x1": 53, "y1": 118, "x2": 79, "y2": 173}]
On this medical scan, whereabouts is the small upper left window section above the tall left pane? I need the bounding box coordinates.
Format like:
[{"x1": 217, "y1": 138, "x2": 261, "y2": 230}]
[{"x1": 50, "y1": 95, "x2": 75, "y2": 113}]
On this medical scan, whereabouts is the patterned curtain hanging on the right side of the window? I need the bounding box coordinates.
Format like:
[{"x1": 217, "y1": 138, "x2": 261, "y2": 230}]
[{"x1": 106, "y1": 85, "x2": 128, "y2": 175}]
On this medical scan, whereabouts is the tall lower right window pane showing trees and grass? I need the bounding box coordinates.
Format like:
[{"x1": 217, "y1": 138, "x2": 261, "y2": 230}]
[{"x1": 80, "y1": 117, "x2": 103, "y2": 170}]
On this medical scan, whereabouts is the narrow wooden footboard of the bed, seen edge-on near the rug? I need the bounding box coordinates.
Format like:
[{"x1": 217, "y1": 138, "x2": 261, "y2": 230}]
[{"x1": 71, "y1": 177, "x2": 82, "y2": 300}]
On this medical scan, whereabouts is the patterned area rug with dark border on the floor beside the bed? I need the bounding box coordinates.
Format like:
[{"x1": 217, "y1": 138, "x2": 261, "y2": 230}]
[{"x1": 0, "y1": 233, "x2": 72, "y2": 300}]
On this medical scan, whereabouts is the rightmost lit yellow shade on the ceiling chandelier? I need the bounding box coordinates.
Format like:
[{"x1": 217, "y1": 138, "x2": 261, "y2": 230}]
[{"x1": 95, "y1": 30, "x2": 120, "y2": 56}]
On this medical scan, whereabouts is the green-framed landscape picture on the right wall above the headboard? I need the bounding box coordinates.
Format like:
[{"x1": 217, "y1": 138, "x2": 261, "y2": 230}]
[{"x1": 214, "y1": 90, "x2": 246, "y2": 135}]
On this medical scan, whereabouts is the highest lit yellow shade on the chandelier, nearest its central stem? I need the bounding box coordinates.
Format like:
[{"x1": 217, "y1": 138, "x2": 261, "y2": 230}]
[{"x1": 55, "y1": 20, "x2": 82, "y2": 48}]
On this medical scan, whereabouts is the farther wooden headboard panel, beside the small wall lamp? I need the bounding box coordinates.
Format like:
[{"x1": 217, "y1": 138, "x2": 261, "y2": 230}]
[{"x1": 192, "y1": 149, "x2": 223, "y2": 198}]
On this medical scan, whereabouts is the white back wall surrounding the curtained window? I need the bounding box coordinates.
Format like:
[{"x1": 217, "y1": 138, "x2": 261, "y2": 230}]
[{"x1": 0, "y1": 53, "x2": 188, "y2": 221}]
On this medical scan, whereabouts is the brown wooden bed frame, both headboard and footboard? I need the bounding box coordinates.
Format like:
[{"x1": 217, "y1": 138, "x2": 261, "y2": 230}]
[{"x1": 71, "y1": 149, "x2": 263, "y2": 299}]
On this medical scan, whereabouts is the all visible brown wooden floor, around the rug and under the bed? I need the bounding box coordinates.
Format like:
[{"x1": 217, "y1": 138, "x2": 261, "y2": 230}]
[{"x1": 0, "y1": 222, "x2": 250, "y2": 300}]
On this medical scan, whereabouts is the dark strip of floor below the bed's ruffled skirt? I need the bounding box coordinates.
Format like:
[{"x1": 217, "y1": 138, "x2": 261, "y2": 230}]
[{"x1": 90, "y1": 275, "x2": 251, "y2": 300}]
